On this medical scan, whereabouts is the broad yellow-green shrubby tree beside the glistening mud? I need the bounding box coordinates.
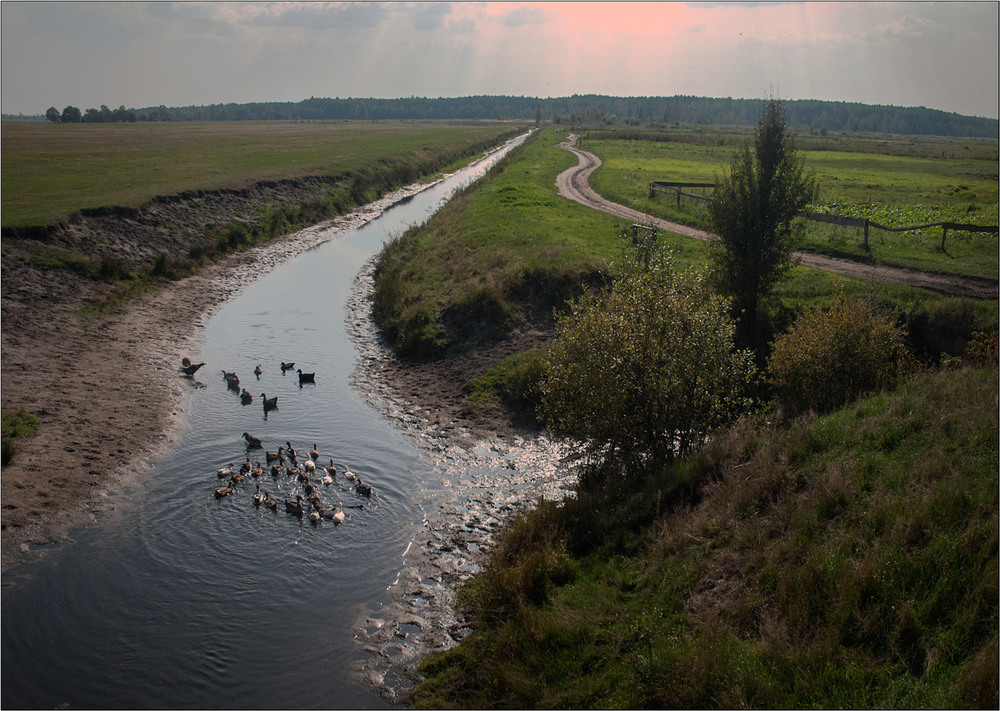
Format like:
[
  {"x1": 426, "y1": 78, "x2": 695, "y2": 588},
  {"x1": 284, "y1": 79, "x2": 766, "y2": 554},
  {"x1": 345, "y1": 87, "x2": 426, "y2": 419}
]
[{"x1": 541, "y1": 252, "x2": 754, "y2": 482}]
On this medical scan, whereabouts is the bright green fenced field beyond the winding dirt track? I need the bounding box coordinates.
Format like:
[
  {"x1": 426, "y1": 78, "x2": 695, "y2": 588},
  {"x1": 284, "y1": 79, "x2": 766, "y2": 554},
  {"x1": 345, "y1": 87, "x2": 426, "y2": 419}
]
[{"x1": 584, "y1": 130, "x2": 998, "y2": 279}]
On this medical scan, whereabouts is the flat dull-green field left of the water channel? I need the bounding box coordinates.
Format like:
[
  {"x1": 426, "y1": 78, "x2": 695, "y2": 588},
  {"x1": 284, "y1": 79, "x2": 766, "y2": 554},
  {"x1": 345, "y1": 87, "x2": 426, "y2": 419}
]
[{"x1": 2, "y1": 121, "x2": 528, "y2": 227}]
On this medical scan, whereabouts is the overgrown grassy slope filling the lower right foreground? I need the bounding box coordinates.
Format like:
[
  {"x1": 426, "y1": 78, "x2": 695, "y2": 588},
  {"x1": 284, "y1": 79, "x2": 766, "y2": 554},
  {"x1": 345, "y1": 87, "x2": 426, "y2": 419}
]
[{"x1": 415, "y1": 367, "x2": 1000, "y2": 708}]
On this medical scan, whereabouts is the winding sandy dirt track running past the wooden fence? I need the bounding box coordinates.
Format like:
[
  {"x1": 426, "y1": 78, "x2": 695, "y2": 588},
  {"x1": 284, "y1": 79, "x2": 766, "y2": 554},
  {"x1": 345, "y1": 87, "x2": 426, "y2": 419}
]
[{"x1": 556, "y1": 134, "x2": 998, "y2": 299}]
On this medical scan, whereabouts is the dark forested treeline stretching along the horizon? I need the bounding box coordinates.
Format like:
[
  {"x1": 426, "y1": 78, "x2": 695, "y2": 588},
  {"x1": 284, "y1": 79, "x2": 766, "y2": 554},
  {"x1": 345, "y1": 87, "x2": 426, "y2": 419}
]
[{"x1": 5, "y1": 94, "x2": 1000, "y2": 138}]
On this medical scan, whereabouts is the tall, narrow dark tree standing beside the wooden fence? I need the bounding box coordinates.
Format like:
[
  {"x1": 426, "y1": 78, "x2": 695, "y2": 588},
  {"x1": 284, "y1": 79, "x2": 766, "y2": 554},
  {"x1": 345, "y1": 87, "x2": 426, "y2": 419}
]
[{"x1": 709, "y1": 98, "x2": 815, "y2": 343}]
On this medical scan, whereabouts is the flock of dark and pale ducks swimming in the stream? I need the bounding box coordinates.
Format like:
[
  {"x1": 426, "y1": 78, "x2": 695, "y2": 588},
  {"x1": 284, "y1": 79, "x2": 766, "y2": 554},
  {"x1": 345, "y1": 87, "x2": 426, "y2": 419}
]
[{"x1": 181, "y1": 358, "x2": 375, "y2": 524}]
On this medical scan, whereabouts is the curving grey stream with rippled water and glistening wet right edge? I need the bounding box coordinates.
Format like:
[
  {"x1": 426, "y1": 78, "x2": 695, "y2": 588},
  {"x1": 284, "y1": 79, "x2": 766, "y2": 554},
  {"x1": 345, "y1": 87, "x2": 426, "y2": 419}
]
[{"x1": 0, "y1": 132, "x2": 569, "y2": 708}]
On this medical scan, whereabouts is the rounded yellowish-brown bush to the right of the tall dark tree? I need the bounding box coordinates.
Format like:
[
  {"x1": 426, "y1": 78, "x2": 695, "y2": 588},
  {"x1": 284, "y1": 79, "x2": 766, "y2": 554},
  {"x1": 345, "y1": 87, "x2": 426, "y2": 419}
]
[{"x1": 767, "y1": 295, "x2": 906, "y2": 412}]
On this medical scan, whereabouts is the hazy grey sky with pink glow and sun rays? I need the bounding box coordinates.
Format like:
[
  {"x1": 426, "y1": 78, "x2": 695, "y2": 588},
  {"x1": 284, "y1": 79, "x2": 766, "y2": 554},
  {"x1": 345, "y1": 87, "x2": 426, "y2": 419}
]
[{"x1": 0, "y1": 0, "x2": 1000, "y2": 118}]
